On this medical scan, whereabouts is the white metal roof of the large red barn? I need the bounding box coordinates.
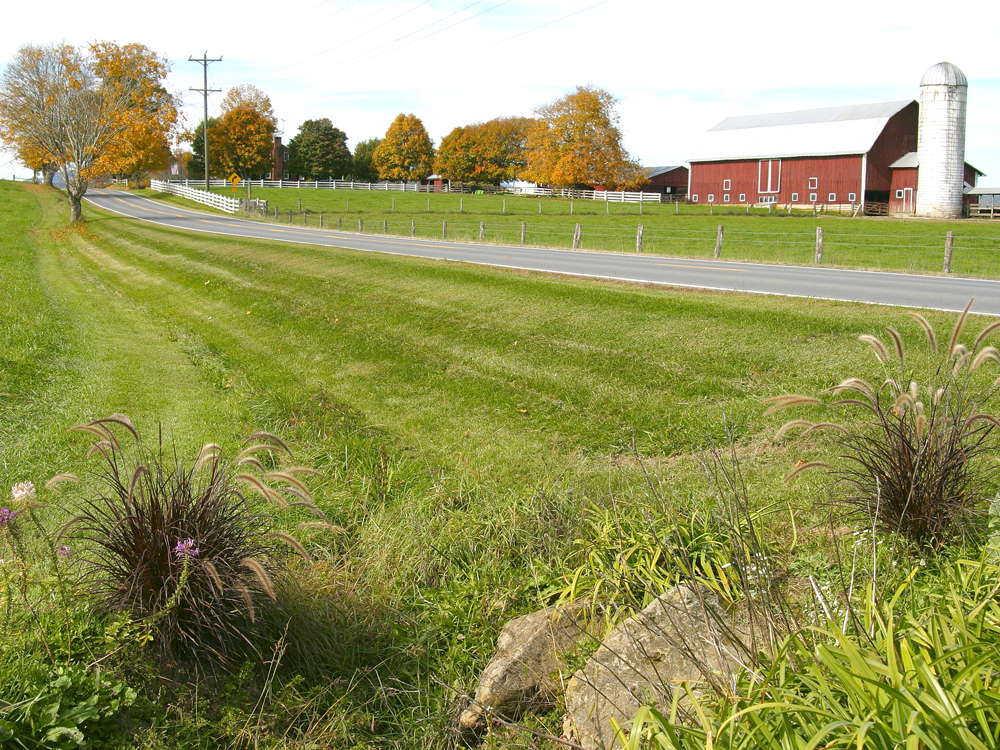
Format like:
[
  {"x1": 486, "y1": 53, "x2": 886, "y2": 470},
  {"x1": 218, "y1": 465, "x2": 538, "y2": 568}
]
[{"x1": 688, "y1": 100, "x2": 913, "y2": 162}]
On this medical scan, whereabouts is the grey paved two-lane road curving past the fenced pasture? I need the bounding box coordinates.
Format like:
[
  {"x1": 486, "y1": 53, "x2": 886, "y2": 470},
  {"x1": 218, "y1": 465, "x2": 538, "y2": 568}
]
[{"x1": 87, "y1": 190, "x2": 1000, "y2": 316}]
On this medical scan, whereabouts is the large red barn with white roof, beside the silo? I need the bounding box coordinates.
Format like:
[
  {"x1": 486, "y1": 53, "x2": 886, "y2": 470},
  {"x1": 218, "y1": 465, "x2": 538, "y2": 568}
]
[{"x1": 688, "y1": 101, "x2": 918, "y2": 212}]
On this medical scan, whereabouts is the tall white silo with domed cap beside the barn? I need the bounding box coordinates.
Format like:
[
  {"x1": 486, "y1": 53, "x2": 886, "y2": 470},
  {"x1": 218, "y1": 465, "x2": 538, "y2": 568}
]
[{"x1": 916, "y1": 62, "x2": 969, "y2": 219}]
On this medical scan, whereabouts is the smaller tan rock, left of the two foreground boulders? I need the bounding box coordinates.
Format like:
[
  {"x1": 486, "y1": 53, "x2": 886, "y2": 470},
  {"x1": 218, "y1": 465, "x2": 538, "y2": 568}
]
[{"x1": 458, "y1": 603, "x2": 597, "y2": 731}]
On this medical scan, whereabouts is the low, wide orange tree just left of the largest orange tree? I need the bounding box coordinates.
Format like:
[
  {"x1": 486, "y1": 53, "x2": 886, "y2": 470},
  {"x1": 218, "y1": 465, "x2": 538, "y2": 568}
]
[{"x1": 434, "y1": 117, "x2": 533, "y2": 185}]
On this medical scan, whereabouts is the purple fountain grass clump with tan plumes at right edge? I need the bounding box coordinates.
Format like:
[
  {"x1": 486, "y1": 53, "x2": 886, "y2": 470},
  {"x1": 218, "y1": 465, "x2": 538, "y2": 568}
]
[{"x1": 765, "y1": 301, "x2": 1000, "y2": 550}]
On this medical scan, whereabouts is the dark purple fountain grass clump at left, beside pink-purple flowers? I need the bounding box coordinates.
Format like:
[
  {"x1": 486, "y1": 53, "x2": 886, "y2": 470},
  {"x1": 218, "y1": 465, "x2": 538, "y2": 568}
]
[{"x1": 49, "y1": 415, "x2": 321, "y2": 669}]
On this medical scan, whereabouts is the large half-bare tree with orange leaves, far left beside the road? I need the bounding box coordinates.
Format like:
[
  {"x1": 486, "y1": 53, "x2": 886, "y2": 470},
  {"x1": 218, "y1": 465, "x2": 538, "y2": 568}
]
[{"x1": 0, "y1": 43, "x2": 177, "y2": 221}]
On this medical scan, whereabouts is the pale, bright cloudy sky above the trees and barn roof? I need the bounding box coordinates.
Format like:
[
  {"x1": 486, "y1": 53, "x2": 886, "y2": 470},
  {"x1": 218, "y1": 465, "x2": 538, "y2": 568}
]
[{"x1": 0, "y1": 0, "x2": 1000, "y2": 185}]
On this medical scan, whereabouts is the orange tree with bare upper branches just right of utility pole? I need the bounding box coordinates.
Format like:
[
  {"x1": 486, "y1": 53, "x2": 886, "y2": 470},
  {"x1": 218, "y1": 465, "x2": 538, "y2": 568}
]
[{"x1": 209, "y1": 84, "x2": 277, "y2": 179}]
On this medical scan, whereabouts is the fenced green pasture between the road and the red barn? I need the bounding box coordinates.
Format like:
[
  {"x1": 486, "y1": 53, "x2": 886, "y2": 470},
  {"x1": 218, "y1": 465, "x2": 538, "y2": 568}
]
[{"x1": 137, "y1": 187, "x2": 1000, "y2": 278}]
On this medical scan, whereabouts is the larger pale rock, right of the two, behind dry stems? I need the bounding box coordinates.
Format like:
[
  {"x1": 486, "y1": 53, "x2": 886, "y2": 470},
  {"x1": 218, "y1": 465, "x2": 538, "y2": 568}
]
[{"x1": 563, "y1": 584, "x2": 739, "y2": 750}]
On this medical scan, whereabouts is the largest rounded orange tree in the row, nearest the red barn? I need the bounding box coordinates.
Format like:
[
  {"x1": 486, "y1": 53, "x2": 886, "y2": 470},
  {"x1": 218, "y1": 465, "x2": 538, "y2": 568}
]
[{"x1": 522, "y1": 86, "x2": 644, "y2": 190}]
